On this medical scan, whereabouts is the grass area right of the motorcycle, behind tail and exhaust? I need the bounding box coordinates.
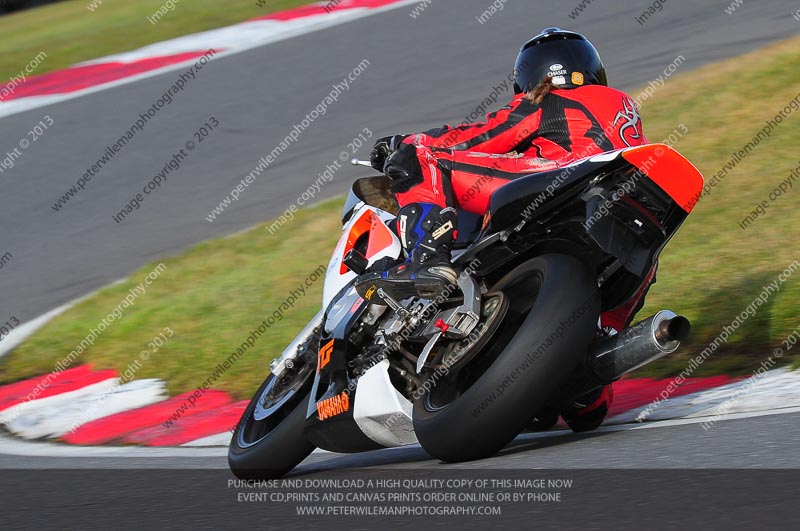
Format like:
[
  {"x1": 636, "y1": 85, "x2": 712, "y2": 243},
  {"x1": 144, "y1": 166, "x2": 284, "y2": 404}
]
[{"x1": 634, "y1": 38, "x2": 800, "y2": 375}]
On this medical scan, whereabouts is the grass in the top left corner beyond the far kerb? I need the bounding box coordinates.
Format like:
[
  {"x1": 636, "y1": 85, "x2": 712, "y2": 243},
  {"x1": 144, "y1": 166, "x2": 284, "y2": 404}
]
[{"x1": 0, "y1": 0, "x2": 311, "y2": 80}]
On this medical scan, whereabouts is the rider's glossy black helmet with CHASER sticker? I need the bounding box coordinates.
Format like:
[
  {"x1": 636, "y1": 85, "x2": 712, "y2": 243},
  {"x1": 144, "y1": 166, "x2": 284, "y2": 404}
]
[{"x1": 514, "y1": 28, "x2": 608, "y2": 94}]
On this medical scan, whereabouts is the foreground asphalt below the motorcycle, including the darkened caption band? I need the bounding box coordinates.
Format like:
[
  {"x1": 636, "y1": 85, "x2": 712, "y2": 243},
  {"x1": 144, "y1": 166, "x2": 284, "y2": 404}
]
[{"x1": 0, "y1": 412, "x2": 800, "y2": 530}]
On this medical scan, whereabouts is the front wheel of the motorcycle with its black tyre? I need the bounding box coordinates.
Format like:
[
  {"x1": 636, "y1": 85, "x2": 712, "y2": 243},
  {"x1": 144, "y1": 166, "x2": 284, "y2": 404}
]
[{"x1": 228, "y1": 334, "x2": 319, "y2": 479}]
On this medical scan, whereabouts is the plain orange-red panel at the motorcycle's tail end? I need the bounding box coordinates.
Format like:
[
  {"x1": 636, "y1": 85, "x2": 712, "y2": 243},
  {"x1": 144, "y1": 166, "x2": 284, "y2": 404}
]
[{"x1": 622, "y1": 144, "x2": 703, "y2": 212}]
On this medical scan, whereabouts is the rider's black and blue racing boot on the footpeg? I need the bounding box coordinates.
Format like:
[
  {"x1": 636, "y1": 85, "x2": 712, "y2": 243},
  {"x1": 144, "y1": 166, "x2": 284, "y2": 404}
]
[{"x1": 355, "y1": 203, "x2": 458, "y2": 300}]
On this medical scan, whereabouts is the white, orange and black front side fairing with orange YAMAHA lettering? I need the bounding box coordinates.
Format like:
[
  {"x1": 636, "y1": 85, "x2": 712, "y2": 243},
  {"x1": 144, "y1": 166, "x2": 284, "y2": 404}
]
[{"x1": 305, "y1": 205, "x2": 416, "y2": 453}]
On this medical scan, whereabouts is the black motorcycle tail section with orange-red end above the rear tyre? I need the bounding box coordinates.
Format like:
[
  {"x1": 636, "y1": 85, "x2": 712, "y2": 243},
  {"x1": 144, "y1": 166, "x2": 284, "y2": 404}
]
[{"x1": 472, "y1": 144, "x2": 703, "y2": 310}]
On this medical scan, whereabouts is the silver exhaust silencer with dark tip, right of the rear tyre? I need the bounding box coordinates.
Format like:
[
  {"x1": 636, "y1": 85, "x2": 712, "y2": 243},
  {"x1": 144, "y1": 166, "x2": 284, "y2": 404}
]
[{"x1": 549, "y1": 310, "x2": 692, "y2": 407}]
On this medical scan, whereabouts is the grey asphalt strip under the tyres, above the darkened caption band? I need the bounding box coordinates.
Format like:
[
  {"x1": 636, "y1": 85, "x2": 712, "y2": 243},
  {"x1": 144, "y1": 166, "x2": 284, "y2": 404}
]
[{"x1": 0, "y1": 408, "x2": 800, "y2": 472}]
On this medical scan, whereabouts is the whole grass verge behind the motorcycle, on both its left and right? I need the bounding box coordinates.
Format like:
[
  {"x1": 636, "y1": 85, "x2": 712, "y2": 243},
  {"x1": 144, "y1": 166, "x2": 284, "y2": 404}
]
[{"x1": 0, "y1": 38, "x2": 800, "y2": 398}]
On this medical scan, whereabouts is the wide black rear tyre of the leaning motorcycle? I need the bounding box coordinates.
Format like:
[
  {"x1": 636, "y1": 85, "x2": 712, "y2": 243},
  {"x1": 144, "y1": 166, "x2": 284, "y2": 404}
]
[{"x1": 413, "y1": 254, "x2": 600, "y2": 462}]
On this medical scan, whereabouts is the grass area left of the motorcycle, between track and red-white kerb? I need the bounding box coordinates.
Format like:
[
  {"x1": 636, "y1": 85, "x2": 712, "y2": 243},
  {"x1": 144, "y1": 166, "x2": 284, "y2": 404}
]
[{"x1": 0, "y1": 199, "x2": 342, "y2": 398}]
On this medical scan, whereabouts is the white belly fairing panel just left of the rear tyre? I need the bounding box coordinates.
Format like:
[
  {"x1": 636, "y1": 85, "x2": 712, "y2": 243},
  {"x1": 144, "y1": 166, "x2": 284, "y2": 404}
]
[{"x1": 353, "y1": 360, "x2": 417, "y2": 448}]
